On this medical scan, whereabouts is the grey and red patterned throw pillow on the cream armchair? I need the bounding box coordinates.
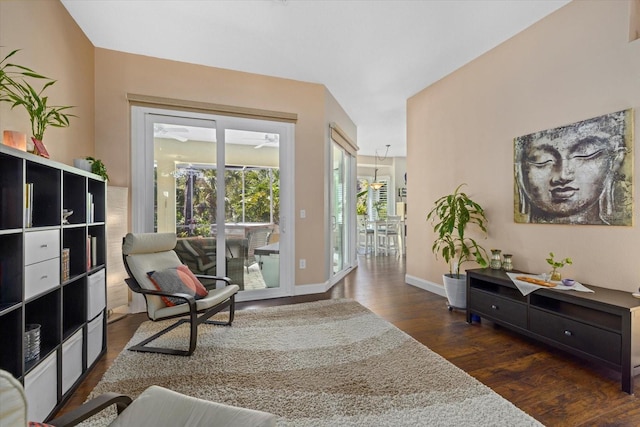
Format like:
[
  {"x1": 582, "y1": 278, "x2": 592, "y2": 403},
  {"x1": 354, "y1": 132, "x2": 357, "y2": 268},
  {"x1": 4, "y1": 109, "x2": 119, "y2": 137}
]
[{"x1": 147, "y1": 265, "x2": 209, "y2": 307}]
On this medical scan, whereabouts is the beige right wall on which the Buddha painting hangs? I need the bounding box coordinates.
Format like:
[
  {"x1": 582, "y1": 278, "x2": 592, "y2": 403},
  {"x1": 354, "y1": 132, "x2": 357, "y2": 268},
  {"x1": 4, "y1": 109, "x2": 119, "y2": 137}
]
[{"x1": 407, "y1": 1, "x2": 640, "y2": 291}]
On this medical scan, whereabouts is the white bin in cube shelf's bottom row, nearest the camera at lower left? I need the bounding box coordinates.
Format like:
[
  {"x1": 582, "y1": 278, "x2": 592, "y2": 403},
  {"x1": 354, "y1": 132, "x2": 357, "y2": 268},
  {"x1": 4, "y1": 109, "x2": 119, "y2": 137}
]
[{"x1": 24, "y1": 353, "x2": 58, "y2": 422}]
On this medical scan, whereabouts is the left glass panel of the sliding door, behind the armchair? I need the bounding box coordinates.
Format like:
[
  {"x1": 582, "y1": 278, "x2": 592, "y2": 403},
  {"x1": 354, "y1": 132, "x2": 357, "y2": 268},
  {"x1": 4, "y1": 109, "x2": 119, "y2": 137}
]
[{"x1": 153, "y1": 116, "x2": 224, "y2": 285}]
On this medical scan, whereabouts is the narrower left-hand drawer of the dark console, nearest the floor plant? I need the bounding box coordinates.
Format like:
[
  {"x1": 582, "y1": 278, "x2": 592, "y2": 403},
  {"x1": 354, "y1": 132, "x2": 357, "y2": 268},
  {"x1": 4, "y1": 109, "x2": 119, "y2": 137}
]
[{"x1": 467, "y1": 289, "x2": 527, "y2": 328}]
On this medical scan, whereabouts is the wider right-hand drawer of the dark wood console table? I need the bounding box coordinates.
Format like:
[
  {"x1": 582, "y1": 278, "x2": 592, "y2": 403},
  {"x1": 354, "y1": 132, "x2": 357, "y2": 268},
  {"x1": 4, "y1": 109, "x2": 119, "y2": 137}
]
[{"x1": 529, "y1": 307, "x2": 622, "y2": 365}]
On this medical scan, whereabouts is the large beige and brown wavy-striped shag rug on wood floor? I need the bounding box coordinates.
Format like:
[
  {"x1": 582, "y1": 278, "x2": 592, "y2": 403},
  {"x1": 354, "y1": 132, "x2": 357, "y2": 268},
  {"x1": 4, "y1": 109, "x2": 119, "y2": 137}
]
[{"x1": 84, "y1": 299, "x2": 541, "y2": 427}]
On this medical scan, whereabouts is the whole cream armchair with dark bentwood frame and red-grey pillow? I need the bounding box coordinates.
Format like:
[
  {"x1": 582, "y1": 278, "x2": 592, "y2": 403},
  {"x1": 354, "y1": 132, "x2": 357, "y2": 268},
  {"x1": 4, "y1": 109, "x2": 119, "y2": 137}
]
[{"x1": 122, "y1": 233, "x2": 240, "y2": 356}]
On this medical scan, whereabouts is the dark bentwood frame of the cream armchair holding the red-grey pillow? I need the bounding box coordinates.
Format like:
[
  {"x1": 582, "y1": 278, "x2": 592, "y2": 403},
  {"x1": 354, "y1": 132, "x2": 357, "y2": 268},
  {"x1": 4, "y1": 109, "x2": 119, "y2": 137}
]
[{"x1": 122, "y1": 233, "x2": 239, "y2": 356}]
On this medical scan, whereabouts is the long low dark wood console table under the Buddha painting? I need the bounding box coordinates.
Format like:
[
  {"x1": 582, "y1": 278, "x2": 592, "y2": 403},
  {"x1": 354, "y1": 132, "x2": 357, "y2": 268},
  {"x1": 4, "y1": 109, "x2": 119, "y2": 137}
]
[{"x1": 467, "y1": 268, "x2": 640, "y2": 394}]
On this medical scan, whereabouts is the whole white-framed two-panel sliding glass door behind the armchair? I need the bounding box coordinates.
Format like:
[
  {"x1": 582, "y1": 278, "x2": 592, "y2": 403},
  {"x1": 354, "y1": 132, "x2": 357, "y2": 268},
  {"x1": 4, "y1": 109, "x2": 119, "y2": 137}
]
[{"x1": 132, "y1": 107, "x2": 293, "y2": 300}]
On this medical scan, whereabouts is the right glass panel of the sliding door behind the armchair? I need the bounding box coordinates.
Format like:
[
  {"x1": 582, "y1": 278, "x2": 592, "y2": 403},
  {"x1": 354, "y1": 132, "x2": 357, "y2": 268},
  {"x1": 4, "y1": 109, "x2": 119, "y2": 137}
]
[{"x1": 224, "y1": 128, "x2": 280, "y2": 291}]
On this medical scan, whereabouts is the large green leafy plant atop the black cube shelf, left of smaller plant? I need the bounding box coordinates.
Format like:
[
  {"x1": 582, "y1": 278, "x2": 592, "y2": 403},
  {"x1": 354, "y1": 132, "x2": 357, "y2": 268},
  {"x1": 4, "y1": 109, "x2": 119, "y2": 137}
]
[{"x1": 2, "y1": 77, "x2": 76, "y2": 141}]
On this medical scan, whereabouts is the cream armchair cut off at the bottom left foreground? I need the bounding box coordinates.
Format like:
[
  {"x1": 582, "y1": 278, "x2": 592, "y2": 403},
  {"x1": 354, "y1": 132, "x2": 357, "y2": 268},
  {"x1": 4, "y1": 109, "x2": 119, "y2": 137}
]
[{"x1": 0, "y1": 370, "x2": 276, "y2": 427}]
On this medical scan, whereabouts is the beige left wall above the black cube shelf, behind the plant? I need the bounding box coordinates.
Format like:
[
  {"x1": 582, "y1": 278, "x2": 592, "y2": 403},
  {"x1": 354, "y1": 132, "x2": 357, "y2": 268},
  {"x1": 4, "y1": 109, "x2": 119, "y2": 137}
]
[{"x1": 0, "y1": 0, "x2": 94, "y2": 165}]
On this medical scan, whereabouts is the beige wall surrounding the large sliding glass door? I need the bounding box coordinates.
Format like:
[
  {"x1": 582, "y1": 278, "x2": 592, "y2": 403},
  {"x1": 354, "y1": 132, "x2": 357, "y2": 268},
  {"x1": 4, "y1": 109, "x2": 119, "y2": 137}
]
[{"x1": 95, "y1": 49, "x2": 355, "y2": 284}]
